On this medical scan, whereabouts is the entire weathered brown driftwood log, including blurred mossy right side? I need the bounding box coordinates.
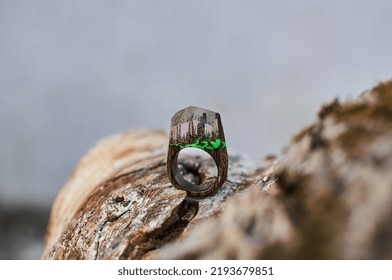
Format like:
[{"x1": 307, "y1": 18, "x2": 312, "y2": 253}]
[{"x1": 43, "y1": 82, "x2": 392, "y2": 259}]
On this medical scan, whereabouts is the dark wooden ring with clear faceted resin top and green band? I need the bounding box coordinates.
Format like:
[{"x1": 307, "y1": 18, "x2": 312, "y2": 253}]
[{"x1": 166, "y1": 106, "x2": 228, "y2": 197}]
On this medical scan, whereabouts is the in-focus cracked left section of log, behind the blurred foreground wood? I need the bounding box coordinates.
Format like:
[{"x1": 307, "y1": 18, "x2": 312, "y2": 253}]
[{"x1": 43, "y1": 131, "x2": 256, "y2": 259}]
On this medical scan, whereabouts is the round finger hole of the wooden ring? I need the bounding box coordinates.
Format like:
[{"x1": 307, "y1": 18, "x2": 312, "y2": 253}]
[{"x1": 177, "y1": 148, "x2": 218, "y2": 186}]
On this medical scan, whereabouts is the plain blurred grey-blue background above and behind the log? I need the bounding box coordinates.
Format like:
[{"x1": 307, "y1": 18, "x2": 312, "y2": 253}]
[{"x1": 0, "y1": 0, "x2": 392, "y2": 259}]
